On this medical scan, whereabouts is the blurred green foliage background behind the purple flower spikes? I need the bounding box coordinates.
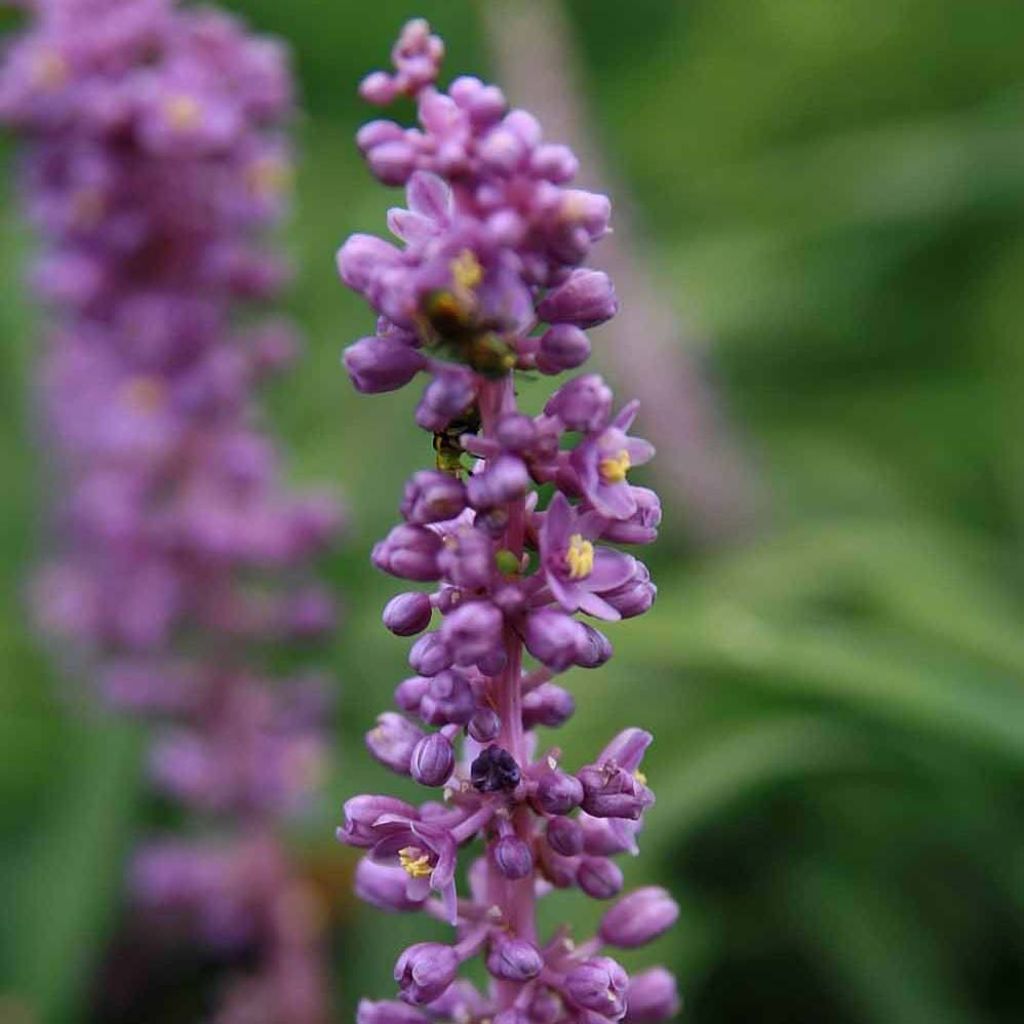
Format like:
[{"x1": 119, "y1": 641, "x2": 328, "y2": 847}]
[{"x1": 0, "y1": 0, "x2": 1024, "y2": 1024}]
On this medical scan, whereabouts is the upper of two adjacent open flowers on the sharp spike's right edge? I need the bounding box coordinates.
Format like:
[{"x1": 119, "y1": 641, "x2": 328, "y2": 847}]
[{"x1": 571, "y1": 401, "x2": 654, "y2": 519}]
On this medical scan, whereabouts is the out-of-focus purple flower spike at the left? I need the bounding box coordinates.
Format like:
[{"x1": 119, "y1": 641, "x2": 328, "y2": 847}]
[{"x1": 0, "y1": 0, "x2": 339, "y2": 1024}]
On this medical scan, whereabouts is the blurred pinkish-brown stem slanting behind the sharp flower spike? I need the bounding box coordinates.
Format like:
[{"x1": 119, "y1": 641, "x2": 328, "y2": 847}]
[{"x1": 480, "y1": 0, "x2": 757, "y2": 544}]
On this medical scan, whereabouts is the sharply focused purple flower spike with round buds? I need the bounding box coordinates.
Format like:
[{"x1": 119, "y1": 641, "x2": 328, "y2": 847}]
[{"x1": 338, "y1": 20, "x2": 679, "y2": 1024}]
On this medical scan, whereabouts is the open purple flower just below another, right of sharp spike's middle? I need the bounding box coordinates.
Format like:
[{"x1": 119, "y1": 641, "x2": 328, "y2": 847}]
[{"x1": 540, "y1": 492, "x2": 636, "y2": 622}]
